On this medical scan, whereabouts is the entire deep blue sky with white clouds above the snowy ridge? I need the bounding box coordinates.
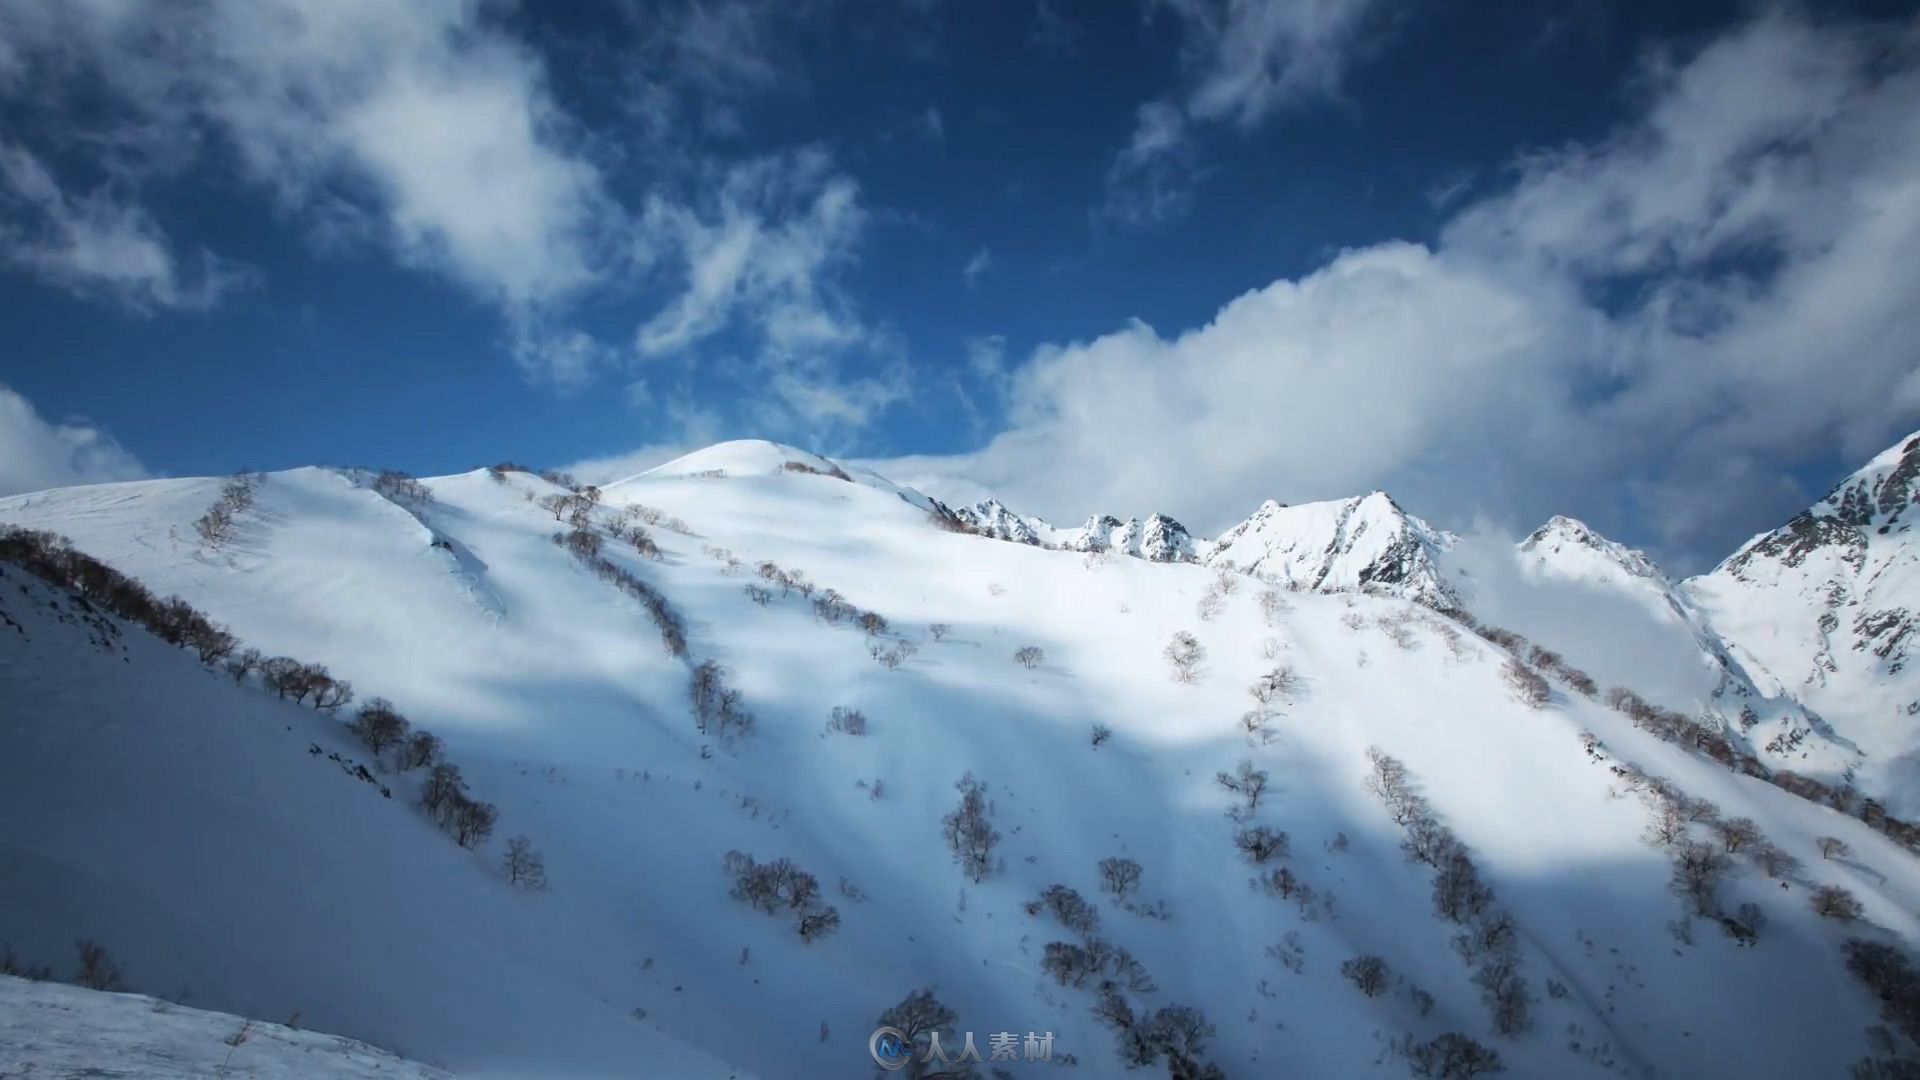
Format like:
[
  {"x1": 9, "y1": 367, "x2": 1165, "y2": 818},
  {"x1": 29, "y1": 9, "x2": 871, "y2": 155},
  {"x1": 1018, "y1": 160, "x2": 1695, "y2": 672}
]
[{"x1": 0, "y1": 0, "x2": 1920, "y2": 569}]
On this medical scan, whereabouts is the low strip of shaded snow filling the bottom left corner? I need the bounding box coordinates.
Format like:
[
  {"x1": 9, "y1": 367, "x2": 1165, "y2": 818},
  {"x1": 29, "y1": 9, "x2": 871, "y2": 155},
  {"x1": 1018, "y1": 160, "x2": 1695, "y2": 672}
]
[{"x1": 0, "y1": 974, "x2": 449, "y2": 1080}]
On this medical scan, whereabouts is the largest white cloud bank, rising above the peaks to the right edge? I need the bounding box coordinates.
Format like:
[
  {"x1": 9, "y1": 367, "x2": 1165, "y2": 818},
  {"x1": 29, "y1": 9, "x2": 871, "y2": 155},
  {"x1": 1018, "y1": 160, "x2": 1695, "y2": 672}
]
[{"x1": 881, "y1": 15, "x2": 1920, "y2": 565}]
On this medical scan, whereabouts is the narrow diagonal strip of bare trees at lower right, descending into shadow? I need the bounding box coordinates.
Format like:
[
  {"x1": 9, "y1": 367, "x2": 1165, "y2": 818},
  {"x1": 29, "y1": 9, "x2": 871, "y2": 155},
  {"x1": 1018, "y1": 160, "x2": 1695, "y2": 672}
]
[{"x1": 1367, "y1": 748, "x2": 1534, "y2": 1036}]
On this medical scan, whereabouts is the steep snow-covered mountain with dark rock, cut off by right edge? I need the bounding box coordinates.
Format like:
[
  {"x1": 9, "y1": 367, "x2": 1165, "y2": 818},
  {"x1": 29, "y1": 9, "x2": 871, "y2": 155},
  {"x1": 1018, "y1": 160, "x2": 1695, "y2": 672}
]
[{"x1": 1684, "y1": 432, "x2": 1920, "y2": 813}]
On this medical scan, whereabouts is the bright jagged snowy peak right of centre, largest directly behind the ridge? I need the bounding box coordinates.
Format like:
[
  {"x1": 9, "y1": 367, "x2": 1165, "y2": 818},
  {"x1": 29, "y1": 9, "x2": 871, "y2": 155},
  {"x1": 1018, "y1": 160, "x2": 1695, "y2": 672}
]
[{"x1": 1200, "y1": 492, "x2": 1459, "y2": 607}]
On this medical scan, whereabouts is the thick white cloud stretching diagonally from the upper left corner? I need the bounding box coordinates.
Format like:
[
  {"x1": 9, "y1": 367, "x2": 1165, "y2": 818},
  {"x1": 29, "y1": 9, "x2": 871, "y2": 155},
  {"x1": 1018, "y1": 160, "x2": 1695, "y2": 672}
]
[{"x1": 0, "y1": 0, "x2": 616, "y2": 332}]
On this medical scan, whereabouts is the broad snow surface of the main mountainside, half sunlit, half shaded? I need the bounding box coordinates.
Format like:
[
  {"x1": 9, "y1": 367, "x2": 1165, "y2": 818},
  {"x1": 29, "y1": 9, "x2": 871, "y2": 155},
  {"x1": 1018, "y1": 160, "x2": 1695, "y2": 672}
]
[{"x1": 0, "y1": 444, "x2": 1920, "y2": 1076}]
